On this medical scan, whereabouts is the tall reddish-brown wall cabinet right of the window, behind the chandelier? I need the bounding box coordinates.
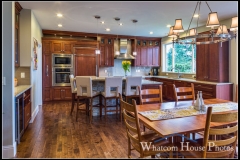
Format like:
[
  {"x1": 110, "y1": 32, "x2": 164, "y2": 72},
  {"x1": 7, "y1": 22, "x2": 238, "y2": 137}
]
[{"x1": 196, "y1": 38, "x2": 229, "y2": 82}]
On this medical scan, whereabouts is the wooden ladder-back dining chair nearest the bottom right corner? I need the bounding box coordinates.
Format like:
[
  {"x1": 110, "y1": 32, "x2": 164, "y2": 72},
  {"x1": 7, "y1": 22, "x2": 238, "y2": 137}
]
[{"x1": 175, "y1": 107, "x2": 238, "y2": 158}]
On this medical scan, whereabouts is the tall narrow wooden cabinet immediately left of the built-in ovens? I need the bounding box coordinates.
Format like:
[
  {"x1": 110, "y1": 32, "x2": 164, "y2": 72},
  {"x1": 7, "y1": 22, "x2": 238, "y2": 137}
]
[{"x1": 42, "y1": 41, "x2": 52, "y2": 101}]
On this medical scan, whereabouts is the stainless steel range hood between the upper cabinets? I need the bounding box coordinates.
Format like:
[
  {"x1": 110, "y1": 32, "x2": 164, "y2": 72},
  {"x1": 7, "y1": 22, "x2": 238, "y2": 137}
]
[{"x1": 114, "y1": 39, "x2": 135, "y2": 59}]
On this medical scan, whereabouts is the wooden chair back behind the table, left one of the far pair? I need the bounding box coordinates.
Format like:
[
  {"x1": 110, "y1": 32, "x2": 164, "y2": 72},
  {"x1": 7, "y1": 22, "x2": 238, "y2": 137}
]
[{"x1": 138, "y1": 85, "x2": 163, "y2": 104}]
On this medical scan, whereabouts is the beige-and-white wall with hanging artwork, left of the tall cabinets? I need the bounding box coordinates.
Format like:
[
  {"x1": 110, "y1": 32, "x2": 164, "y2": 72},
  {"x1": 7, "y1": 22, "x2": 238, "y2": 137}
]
[{"x1": 20, "y1": 9, "x2": 42, "y2": 122}]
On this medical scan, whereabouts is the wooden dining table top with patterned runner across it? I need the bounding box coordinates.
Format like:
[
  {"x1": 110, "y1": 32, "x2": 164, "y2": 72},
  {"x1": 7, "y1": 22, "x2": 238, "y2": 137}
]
[{"x1": 136, "y1": 99, "x2": 238, "y2": 137}]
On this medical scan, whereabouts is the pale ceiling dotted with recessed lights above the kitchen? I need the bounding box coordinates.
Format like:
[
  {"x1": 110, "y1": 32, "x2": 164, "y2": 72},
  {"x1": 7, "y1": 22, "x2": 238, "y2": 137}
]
[{"x1": 19, "y1": 1, "x2": 238, "y2": 37}]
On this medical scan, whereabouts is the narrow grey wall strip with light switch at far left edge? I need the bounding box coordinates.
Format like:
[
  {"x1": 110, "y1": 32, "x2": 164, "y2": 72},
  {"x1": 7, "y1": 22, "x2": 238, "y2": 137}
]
[{"x1": 2, "y1": 2, "x2": 16, "y2": 158}]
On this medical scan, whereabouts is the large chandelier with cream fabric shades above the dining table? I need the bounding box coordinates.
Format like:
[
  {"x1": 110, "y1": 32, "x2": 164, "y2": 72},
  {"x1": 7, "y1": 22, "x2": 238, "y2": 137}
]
[{"x1": 172, "y1": 1, "x2": 238, "y2": 44}]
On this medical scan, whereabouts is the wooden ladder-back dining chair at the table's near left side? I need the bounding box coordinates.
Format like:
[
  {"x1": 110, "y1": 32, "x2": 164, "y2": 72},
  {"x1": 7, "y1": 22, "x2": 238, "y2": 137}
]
[{"x1": 119, "y1": 94, "x2": 172, "y2": 158}]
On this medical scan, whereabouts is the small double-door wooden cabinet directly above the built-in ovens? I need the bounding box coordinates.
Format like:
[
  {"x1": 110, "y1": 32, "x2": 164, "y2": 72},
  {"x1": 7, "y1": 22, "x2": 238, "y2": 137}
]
[{"x1": 52, "y1": 41, "x2": 74, "y2": 54}]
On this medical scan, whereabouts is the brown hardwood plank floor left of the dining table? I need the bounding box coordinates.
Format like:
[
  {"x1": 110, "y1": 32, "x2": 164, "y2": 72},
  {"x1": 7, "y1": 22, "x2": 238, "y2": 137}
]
[{"x1": 16, "y1": 101, "x2": 139, "y2": 158}]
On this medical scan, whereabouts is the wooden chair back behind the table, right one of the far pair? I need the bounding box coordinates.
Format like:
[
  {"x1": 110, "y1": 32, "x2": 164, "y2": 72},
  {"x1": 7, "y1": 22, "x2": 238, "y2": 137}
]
[{"x1": 173, "y1": 83, "x2": 195, "y2": 102}]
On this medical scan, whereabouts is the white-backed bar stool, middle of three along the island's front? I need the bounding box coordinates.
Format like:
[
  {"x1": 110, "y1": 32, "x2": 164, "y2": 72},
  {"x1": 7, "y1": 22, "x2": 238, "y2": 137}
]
[{"x1": 102, "y1": 77, "x2": 122, "y2": 120}]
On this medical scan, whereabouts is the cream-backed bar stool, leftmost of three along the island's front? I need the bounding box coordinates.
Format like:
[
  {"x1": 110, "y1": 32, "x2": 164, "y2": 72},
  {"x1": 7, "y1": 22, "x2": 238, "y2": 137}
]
[{"x1": 76, "y1": 76, "x2": 101, "y2": 123}]
